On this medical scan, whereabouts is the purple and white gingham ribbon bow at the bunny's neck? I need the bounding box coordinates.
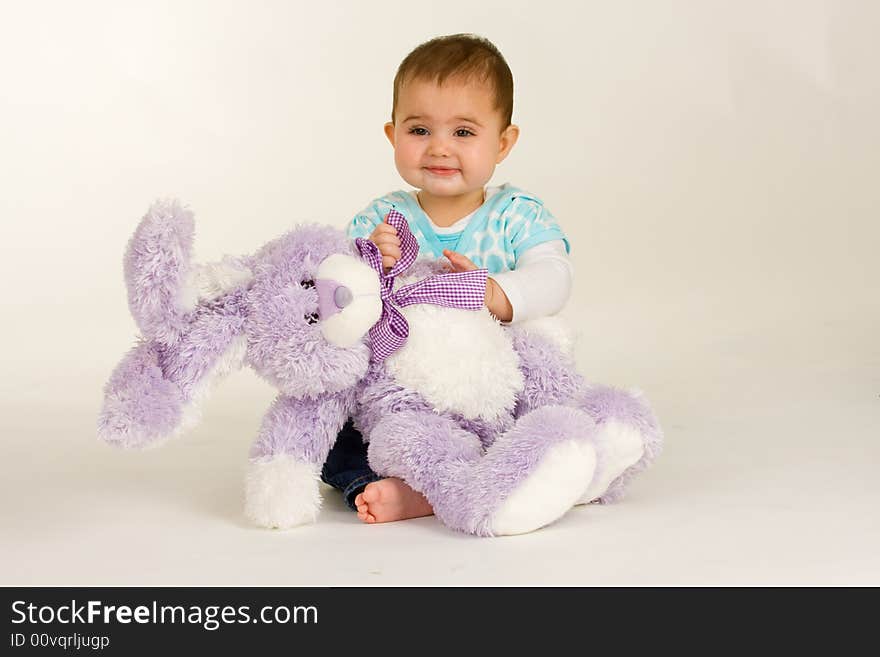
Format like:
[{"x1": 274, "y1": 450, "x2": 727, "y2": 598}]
[{"x1": 355, "y1": 210, "x2": 489, "y2": 361}]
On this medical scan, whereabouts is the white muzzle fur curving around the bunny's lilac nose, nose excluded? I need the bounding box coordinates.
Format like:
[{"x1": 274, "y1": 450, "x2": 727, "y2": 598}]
[{"x1": 315, "y1": 253, "x2": 382, "y2": 347}]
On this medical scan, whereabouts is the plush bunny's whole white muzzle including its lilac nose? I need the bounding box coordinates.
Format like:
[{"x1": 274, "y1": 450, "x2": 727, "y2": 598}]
[{"x1": 315, "y1": 253, "x2": 382, "y2": 347}]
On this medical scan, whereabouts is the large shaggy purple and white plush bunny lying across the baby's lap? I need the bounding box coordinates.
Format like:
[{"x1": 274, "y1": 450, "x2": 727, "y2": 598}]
[{"x1": 98, "y1": 202, "x2": 661, "y2": 535}]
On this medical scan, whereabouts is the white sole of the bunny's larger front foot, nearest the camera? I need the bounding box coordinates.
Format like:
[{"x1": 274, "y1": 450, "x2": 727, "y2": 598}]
[{"x1": 491, "y1": 440, "x2": 596, "y2": 536}]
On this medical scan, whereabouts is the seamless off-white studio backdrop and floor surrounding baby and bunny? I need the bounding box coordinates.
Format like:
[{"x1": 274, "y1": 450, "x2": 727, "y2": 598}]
[{"x1": 0, "y1": 0, "x2": 880, "y2": 586}]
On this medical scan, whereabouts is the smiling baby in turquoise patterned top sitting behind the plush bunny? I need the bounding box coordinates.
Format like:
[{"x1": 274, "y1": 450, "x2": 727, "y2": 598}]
[{"x1": 321, "y1": 34, "x2": 571, "y2": 523}]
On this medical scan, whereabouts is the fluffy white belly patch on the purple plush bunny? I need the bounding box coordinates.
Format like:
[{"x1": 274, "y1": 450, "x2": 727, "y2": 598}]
[{"x1": 385, "y1": 304, "x2": 523, "y2": 420}]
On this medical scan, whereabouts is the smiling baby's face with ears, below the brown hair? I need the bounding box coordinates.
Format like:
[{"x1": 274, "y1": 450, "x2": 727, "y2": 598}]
[{"x1": 385, "y1": 80, "x2": 518, "y2": 197}]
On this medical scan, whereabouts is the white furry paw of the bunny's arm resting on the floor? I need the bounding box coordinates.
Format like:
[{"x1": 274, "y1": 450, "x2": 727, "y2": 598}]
[{"x1": 244, "y1": 454, "x2": 321, "y2": 529}]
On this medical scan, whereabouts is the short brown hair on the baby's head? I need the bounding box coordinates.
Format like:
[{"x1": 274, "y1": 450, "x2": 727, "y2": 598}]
[{"x1": 391, "y1": 34, "x2": 513, "y2": 128}]
